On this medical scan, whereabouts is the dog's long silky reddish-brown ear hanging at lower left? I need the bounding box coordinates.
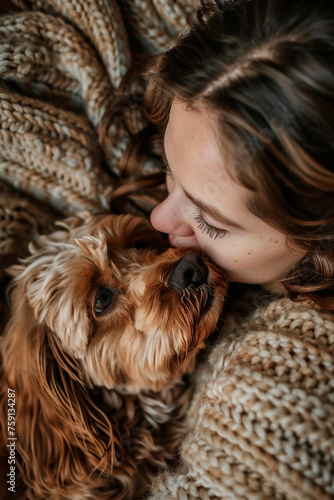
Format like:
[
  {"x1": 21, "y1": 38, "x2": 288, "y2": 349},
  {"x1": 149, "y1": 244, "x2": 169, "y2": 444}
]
[{"x1": 0, "y1": 288, "x2": 123, "y2": 498}]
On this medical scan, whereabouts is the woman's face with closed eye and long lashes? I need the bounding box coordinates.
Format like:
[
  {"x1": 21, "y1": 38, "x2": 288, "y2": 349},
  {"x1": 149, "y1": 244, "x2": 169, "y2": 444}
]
[{"x1": 151, "y1": 101, "x2": 303, "y2": 286}]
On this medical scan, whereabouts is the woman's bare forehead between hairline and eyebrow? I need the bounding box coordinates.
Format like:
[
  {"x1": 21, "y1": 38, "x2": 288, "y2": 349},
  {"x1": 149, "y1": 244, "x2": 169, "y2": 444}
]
[{"x1": 164, "y1": 101, "x2": 258, "y2": 229}]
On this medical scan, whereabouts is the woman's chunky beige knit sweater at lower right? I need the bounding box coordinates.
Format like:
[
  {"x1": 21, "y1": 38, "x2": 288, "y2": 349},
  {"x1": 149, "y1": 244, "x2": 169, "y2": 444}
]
[{"x1": 150, "y1": 299, "x2": 334, "y2": 500}]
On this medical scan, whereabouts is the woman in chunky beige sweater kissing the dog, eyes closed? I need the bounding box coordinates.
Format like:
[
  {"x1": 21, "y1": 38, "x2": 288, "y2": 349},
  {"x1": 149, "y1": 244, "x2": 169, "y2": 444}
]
[{"x1": 146, "y1": 0, "x2": 334, "y2": 500}]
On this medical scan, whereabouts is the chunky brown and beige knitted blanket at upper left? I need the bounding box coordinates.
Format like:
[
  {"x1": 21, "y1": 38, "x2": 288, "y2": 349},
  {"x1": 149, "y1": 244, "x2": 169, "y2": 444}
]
[{"x1": 0, "y1": 0, "x2": 194, "y2": 292}]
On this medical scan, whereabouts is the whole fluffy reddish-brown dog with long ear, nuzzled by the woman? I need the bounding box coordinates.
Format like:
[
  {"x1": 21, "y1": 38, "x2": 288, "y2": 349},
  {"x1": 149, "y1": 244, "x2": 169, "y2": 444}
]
[{"x1": 0, "y1": 214, "x2": 226, "y2": 500}]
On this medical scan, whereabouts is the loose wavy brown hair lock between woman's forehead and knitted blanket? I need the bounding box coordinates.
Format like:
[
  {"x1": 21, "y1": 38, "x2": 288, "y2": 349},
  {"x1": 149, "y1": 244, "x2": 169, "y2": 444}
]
[{"x1": 99, "y1": 57, "x2": 166, "y2": 215}]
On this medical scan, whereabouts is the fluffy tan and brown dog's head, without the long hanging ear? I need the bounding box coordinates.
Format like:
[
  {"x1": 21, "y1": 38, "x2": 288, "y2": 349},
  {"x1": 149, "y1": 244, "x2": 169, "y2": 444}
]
[{"x1": 8, "y1": 214, "x2": 226, "y2": 392}]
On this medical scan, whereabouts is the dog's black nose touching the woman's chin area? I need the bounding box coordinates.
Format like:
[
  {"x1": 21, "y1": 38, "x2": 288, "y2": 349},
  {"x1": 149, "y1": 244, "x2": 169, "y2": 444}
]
[{"x1": 168, "y1": 252, "x2": 209, "y2": 290}]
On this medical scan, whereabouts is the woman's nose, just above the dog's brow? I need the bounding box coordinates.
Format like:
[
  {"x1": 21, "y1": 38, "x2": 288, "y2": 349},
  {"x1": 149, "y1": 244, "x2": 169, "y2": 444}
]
[{"x1": 151, "y1": 194, "x2": 193, "y2": 236}]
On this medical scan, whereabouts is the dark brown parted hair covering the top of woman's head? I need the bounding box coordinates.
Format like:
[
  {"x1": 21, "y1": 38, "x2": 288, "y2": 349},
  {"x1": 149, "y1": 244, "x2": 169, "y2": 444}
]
[{"x1": 145, "y1": 0, "x2": 334, "y2": 310}]
